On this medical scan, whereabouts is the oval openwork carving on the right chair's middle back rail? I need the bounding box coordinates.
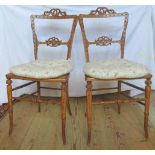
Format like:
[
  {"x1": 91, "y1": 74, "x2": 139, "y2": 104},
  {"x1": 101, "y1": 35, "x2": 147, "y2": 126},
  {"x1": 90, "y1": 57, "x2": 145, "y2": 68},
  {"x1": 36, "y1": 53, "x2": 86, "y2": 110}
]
[{"x1": 95, "y1": 36, "x2": 112, "y2": 46}]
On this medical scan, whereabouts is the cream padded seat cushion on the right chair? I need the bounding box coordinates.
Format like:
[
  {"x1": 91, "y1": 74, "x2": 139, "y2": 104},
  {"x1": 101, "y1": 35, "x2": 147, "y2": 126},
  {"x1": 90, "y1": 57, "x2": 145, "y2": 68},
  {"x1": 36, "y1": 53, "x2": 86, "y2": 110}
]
[{"x1": 84, "y1": 59, "x2": 149, "y2": 79}]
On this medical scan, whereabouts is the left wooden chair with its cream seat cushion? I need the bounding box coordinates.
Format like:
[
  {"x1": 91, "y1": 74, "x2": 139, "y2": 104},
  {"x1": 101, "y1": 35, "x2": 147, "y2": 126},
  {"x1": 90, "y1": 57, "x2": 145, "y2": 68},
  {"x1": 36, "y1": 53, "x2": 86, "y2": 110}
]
[{"x1": 6, "y1": 8, "x2": 78, "y2": 144}]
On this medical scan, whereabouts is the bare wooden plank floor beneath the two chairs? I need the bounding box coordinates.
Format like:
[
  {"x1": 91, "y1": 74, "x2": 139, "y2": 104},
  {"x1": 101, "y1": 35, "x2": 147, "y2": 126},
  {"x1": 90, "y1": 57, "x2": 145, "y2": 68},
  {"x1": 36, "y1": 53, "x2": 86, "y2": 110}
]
[{"x1": 0, "y1": 92, "x2": 155, "y2": 150}]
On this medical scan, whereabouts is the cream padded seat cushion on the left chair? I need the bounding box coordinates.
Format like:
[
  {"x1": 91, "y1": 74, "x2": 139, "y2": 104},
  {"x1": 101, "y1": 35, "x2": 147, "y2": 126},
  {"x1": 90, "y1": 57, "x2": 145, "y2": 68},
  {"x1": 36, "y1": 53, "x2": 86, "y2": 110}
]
[{"x1": 10, "y1": 60, "x2": 72, "y2": 79}]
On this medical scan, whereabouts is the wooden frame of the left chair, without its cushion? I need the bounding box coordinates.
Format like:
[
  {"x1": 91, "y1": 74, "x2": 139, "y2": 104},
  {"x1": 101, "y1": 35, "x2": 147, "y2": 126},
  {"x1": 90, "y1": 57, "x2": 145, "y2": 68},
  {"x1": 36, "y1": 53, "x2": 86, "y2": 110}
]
[{"x1": 6, "y1": 8, "x2": 78, "y2": 144}]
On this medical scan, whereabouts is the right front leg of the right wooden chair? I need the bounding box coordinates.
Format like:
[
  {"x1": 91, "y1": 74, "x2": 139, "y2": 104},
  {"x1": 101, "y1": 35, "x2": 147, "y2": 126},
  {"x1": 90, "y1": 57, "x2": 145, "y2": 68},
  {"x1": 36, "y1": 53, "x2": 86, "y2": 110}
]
[{"x1": 144, "y1": 78, "x2": 151, "y2": 139}]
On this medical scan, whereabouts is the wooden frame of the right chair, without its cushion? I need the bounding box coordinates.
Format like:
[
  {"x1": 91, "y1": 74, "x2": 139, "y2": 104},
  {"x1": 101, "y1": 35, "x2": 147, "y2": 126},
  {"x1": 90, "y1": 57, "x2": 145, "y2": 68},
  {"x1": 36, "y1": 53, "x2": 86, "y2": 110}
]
[{"x1": 79, "y1": 7, "x2": 152, "y2": 144}]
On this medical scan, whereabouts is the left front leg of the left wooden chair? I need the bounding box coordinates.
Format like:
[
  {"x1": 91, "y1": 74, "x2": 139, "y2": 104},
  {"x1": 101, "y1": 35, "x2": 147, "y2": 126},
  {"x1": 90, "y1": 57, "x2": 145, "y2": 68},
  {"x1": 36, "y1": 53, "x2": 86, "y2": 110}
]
[{"x1": 6, "y1": 79, "x2": 13, "y2": 135}]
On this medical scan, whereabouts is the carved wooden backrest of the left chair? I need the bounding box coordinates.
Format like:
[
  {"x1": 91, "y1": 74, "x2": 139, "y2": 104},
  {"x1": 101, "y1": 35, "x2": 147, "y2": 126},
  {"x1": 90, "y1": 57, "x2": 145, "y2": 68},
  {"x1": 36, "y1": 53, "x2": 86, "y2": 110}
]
[{"x1": 31, "y1": 8, "x2": 78, "y2": 60}]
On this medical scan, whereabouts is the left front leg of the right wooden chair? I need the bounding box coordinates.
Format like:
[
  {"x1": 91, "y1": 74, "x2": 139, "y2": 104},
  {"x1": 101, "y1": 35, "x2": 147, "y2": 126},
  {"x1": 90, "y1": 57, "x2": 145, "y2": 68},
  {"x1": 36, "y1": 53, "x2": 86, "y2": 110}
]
[{"x1": 86, "y1": 81, "x2": 92, "y2": 144}]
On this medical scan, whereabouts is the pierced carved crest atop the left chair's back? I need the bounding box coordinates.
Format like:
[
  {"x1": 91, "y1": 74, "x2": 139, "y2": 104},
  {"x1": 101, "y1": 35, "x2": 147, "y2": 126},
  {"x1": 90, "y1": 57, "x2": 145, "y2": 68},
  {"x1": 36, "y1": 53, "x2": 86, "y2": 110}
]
[{"x1": 44, "y1": 8, "x2": 67, "y2": 16}]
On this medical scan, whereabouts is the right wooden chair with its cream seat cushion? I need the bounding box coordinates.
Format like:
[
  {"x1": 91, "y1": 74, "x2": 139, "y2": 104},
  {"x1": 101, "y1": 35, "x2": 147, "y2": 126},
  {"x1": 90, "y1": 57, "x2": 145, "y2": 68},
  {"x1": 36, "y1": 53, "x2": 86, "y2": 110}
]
[{"x1": 79, "y1": 7, "x2": 152, "y2": 143}]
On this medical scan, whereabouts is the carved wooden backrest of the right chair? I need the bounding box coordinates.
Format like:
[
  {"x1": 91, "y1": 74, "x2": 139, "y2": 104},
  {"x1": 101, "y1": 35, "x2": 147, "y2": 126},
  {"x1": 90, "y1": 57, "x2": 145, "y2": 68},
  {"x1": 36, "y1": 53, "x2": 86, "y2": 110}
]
[{"x1": 79, "y1": 7, "x2": 129, "y2": 62}]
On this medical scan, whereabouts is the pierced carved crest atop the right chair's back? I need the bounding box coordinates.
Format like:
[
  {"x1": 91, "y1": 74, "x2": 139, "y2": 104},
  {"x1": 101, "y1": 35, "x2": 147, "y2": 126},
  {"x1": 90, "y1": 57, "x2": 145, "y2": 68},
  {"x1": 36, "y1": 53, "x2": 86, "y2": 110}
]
[{"x1": 89, "y1": 7, "x2": 116, "y2": 16}]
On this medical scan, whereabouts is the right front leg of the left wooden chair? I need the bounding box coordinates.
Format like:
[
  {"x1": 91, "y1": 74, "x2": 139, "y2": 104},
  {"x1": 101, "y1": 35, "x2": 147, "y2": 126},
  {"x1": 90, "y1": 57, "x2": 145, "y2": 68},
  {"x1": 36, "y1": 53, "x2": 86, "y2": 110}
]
[{"x1": 61, "y1": 82, "x2": 67, "y2": 144}]
